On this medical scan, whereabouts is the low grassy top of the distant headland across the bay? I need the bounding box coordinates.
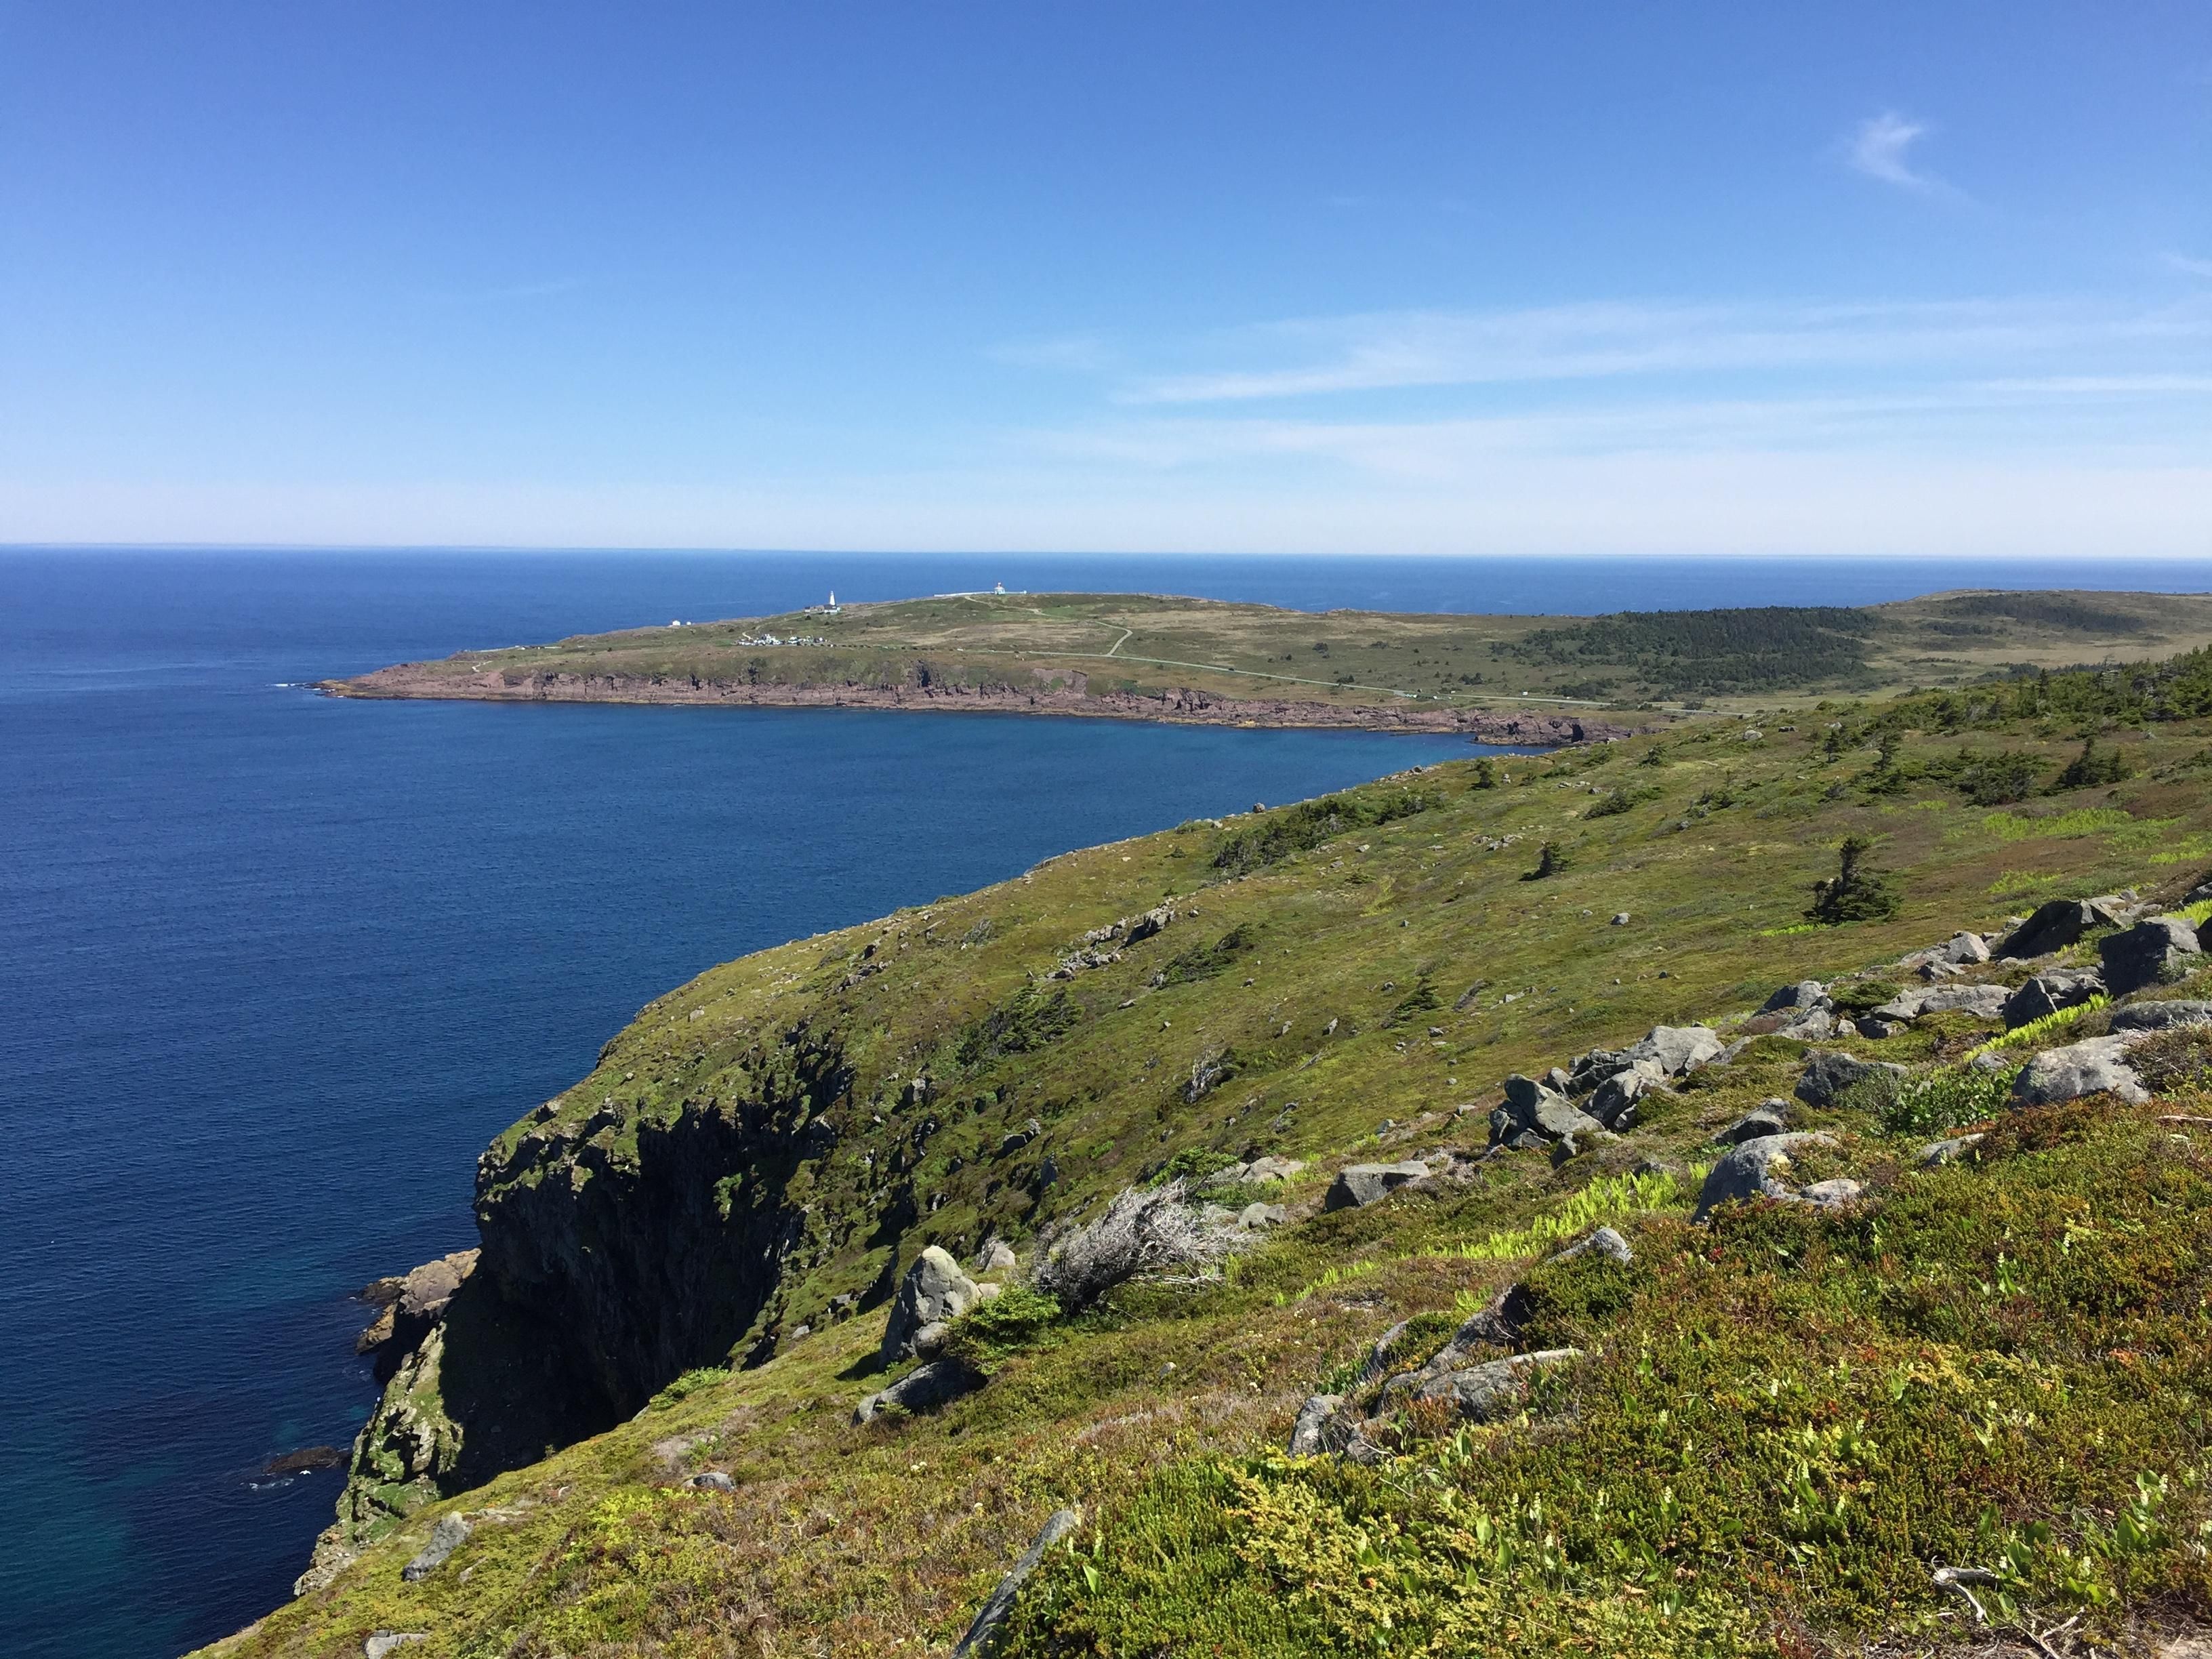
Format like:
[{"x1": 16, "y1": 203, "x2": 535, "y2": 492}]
[{"x1": 325, "y1": 593, "x2": 2212, "y2": 728}]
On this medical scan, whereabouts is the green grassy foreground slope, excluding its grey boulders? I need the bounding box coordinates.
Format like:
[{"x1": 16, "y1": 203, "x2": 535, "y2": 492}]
[{"x1": 208, "y1": 661, "x2": 2212, "y2": 1659}]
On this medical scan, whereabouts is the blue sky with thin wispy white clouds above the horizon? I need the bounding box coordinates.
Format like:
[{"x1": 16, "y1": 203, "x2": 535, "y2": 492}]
[{"x1": 0, "y1": 0, "x2": 2212, "y2": 555}]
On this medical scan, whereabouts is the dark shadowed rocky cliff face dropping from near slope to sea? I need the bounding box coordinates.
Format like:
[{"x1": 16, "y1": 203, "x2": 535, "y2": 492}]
[{"x1": 312, "y1": 1029, "x2": 872, "y2": 1593}]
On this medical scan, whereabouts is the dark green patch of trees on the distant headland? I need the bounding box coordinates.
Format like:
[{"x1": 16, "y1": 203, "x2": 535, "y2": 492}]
[{"x1": 1498, "y1": 606, "x2": 1880, "y2": 697}]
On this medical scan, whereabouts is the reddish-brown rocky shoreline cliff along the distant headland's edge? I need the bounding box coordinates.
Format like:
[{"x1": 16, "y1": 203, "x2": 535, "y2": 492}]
[{"x1": 319, "y1": 663, "x2": 1631, "y2": 745}]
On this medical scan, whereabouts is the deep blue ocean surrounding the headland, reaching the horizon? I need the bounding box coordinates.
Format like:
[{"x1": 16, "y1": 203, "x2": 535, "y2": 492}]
[{"x1": 0, "y1": 548, "x2": 2212, "y2": 1659}]
